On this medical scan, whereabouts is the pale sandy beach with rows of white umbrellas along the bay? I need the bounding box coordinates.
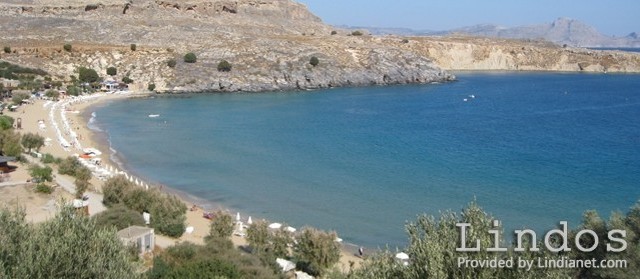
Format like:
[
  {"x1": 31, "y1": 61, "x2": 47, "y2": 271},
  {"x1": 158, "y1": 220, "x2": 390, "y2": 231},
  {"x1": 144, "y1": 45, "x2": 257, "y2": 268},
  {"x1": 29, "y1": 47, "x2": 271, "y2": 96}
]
[{"x1": 0, "y1": 93, "x2": 362, "y2": 271}]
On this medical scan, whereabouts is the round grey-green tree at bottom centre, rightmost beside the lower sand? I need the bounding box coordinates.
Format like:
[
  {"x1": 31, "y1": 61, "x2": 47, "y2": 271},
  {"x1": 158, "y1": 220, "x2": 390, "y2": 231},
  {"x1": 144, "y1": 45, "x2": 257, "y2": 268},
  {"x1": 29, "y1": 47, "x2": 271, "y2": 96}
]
[{"x1": 294, "y1": 228, "x2": 340, "y2": 276}]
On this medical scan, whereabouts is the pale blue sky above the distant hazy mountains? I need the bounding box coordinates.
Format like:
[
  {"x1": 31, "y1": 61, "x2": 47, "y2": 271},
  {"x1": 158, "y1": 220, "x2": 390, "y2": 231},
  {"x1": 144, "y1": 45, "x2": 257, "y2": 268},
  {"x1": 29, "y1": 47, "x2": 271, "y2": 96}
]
[{"x1": 297, "y1": 0, "x2": 640, "y2": 36}]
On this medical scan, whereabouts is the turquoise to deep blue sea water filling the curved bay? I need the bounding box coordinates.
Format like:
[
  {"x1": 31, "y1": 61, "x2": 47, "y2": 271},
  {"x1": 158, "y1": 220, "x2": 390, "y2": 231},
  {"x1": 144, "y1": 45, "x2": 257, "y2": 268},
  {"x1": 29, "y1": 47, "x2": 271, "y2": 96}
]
[{"x1": 92, "y1": 73, "x2": 640, "y2": 247}]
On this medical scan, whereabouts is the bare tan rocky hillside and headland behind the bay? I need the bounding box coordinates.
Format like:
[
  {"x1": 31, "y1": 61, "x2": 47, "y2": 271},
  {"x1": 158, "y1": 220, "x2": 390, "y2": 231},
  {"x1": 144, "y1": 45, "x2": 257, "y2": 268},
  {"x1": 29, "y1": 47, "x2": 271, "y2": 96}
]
[{"x1": 0, "y1": 0, "x2": 640, "y2": 92}]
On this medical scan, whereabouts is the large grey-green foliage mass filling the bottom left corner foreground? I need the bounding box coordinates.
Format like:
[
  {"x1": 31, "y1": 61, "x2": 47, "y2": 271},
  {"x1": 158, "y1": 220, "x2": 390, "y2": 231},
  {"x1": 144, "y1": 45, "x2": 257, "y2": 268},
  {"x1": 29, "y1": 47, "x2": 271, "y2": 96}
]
[{"x1": 0, "y1": 207, "x2": 140, "y2": 279}]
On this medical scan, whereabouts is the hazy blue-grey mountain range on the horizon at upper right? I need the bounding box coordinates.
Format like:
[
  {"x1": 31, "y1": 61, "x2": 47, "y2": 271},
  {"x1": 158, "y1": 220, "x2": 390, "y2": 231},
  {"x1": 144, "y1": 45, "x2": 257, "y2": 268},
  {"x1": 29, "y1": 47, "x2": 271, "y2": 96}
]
[{"x1": 344, "y1": 18, "x2": 640, "y2": 47}]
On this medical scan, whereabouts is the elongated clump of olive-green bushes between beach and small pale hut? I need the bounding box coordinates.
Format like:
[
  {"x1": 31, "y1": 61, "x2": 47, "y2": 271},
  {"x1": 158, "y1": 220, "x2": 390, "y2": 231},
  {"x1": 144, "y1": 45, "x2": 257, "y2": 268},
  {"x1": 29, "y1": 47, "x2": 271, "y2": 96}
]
[{"x1": 102, "y1": 176, "x2": 187, "y2": 237}]
